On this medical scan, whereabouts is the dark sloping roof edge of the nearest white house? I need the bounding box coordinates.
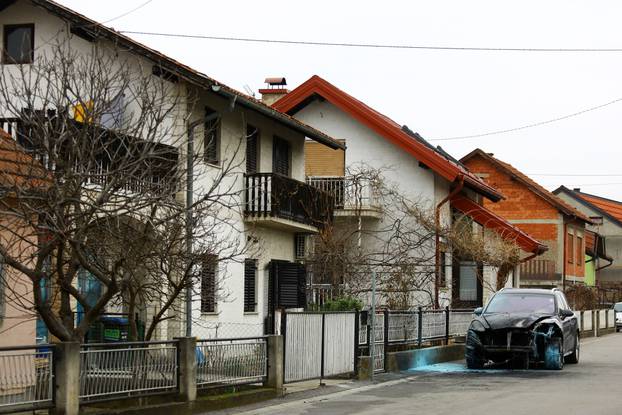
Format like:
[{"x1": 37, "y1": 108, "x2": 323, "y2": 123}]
[{"x1": 23, "y1": 0, "x2": 345, "y2": 149}]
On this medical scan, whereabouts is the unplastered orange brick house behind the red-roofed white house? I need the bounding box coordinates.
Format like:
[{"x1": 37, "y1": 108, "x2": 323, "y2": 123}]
[{"x1": 461, "y1": 149, "x2": 592, "y2": 287}]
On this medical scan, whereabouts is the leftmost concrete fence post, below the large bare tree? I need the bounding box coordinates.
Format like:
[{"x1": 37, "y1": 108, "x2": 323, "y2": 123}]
[{"x1": 53, "y1": 342, "x2": 80, "y2": 415}]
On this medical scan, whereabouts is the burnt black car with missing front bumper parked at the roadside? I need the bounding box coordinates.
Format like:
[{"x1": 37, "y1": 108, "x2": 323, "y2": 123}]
[{"x1": 465, "y1": 288, "x2": 580, "y2": 370}]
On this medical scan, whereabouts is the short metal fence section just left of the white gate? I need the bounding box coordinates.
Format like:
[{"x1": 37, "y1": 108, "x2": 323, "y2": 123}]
[{"x1": 196, "y1": 337, "x2": 268, "y2": 388}]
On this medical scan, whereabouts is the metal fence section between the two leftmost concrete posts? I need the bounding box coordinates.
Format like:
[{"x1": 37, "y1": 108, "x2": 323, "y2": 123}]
[{"x1": 80, "y1": 341, "x2": 178, "y2": 401}]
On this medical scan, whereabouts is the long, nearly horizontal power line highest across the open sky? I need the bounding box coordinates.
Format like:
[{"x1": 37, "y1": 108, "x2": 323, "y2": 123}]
[{"x1": 120, "y1": 30, "x2": 622, "y2": 53}]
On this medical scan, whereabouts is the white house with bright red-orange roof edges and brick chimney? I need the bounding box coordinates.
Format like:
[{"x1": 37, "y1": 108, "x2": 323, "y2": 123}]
[{"x1": 268, "y1": 75, "x2": 544, "y2": 307}]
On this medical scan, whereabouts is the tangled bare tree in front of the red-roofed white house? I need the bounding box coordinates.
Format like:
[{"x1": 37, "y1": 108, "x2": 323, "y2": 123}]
[{"x1": 307, "y1": 165, "x2": 520, "y2": 309}]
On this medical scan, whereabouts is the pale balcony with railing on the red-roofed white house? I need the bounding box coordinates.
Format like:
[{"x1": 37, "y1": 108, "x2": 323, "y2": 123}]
[{"x1": 307, "y1": 176, "x2": 382, "y2": 218}]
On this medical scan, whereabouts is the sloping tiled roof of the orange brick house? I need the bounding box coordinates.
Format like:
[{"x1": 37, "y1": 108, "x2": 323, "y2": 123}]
[{"x1": 460, "y1": 148, "x2": 592, "y2": 224}]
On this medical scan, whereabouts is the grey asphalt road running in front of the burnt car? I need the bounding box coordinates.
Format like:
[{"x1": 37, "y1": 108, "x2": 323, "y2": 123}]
[{"x1": 240, "y1": 333, "x2": 622, "y2": 415}]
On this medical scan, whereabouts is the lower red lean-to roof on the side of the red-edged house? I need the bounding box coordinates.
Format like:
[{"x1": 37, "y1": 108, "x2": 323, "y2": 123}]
[{"x1": 450, "y1": 195, "x2": 548, "y2": 255}]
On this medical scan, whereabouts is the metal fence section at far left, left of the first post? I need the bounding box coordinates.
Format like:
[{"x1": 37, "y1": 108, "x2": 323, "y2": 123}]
[{"x1": 0, "y1": 345, "x2": 54, "y2": 412}]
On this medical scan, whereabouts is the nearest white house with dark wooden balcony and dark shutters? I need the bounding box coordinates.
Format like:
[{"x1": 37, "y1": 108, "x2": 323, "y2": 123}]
[{"x1": 0, "y1": 0, "x2": 344, "y2": 338}]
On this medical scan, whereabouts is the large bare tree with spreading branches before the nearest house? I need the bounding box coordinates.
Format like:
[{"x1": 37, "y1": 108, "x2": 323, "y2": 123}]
[{"x1": 0, "y1": 42, "x2": 245, "y2": 341}]
